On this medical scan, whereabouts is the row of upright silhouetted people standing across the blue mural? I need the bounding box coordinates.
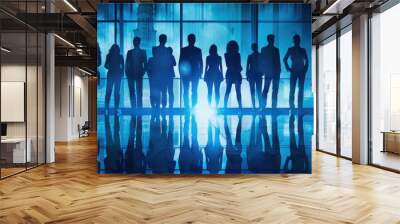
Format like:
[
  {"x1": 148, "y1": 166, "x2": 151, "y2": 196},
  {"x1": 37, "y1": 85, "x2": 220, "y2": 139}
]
[{"x1": 98, "y1": 34, "x2": 309, "y2": 109}]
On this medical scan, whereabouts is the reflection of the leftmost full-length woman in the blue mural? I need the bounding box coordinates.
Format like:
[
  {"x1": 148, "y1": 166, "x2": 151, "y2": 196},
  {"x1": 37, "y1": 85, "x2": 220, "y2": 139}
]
[{"x1": 104, "y1": 115, "x2": 123, "y2": 173}]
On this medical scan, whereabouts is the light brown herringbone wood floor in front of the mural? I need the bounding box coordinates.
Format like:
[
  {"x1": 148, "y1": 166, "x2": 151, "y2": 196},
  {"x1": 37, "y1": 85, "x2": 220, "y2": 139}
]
[{"x1": 0, "y1": 138, "x2": 400, "y2": 224}]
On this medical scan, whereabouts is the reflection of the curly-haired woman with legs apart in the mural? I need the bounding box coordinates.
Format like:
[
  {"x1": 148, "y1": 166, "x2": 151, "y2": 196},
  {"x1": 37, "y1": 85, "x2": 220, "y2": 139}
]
[{"x1": 224, "y1": 116, "x2": 243, "y2": 173}]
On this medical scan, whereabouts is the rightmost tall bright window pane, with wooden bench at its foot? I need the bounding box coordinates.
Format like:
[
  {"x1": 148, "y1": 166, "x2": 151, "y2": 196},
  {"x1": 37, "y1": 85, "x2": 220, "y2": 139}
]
[{"x1": 370, "y1": 4, "x2": 400, "y2": 170}]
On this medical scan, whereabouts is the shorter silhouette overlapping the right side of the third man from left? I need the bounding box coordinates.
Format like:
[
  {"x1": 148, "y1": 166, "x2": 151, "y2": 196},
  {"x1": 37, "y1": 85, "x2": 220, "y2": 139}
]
[{"x1": 161, "y1": 47, "x2": 176, "y2": 108}]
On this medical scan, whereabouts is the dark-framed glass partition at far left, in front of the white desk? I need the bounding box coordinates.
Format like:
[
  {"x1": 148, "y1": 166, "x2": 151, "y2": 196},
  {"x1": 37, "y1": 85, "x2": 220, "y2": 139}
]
[{"x1": 0, "y1": 1, "x2": 46, "y2": 178}]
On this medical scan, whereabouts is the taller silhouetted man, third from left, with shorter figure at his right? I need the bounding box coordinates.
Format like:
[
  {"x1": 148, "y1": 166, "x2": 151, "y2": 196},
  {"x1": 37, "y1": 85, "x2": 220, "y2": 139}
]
[{"x1": 152, "y1": 34, "x2": 171, "y2": 108}]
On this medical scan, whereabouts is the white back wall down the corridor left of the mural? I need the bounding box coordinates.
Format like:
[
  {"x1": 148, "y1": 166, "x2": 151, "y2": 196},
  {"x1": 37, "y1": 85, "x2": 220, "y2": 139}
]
[{"x1": 55, "y1": 67, "x2": 88, "y2": 141}]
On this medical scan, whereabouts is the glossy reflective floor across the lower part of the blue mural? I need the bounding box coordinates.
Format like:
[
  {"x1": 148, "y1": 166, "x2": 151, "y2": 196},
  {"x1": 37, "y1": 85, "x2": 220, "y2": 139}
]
[{"x1": 98, "y1": 110, "x2": 313, "y2": 174}]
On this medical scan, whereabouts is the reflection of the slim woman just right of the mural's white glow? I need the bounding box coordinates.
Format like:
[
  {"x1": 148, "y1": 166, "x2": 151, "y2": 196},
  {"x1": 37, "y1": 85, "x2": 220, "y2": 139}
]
[{"x1": 204, "y1": 121, "x2": 223, "y2": 174}]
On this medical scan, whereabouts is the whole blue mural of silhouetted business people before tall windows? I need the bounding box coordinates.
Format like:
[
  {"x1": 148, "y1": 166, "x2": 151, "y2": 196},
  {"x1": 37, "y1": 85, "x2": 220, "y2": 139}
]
[{"x1": 97, "y1": 3, "x2": 314, "y2": 174}]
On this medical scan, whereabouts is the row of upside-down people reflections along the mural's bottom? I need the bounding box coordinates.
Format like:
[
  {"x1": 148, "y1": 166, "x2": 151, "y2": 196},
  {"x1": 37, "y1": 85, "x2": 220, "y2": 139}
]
[{"x1": 100, "y1": 115, "x2": 311, "y2": 174}]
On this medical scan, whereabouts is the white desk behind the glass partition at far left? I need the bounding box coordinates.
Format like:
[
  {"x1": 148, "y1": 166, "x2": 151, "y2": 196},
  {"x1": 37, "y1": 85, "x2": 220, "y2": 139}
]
[{"x1": 1, "y1": 138, "x2": 32, "y2": 163}]
